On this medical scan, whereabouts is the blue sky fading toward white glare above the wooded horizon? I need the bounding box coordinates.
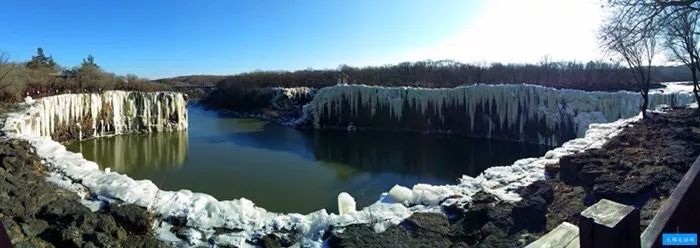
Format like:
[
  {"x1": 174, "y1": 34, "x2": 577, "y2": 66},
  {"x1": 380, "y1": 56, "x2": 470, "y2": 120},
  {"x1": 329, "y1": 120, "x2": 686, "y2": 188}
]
[{"x1": 0, "y1": 0, "x2": 608, "y2": 78}]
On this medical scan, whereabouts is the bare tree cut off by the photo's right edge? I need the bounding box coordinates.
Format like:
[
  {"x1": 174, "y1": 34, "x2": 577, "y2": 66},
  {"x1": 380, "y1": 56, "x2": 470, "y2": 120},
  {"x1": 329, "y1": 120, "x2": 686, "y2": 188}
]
[{"x1": 664, "y1": 10, "x2": 700, "y2": 103}]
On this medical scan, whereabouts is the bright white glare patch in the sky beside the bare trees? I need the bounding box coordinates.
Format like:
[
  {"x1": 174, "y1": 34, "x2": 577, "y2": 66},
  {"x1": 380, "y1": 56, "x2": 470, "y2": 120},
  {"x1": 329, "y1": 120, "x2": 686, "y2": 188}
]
[{"x1": 407, "y1": 0, "x2": 604, "y2": 63}]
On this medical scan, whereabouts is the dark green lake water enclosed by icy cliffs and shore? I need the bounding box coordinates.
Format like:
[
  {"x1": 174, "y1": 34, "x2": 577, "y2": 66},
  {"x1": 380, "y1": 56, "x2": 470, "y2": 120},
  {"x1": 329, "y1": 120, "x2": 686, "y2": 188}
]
[{"x1": 67, "y1": 104, "x2": 548, "y2": 213}]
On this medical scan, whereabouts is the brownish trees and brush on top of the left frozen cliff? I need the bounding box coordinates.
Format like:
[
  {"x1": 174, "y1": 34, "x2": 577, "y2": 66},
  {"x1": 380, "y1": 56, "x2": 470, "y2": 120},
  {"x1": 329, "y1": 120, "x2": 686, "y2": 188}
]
[{"x1": 0, "y1": 48, "x2": 168, "y2": 101}]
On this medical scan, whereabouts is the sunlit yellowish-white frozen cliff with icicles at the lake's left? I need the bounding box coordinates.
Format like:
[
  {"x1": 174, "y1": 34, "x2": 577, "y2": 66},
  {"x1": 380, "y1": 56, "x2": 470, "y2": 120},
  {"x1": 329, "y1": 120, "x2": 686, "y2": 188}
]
[{"x1": 4, "y1": 91, "x2": 187, "y2": 140}]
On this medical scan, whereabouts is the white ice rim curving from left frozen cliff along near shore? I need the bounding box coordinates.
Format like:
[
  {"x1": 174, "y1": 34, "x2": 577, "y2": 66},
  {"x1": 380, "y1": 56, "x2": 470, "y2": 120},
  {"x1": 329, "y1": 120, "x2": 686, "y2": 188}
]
[{"x1": 3, "y1": 85, "x2": 696, "y2": 247}]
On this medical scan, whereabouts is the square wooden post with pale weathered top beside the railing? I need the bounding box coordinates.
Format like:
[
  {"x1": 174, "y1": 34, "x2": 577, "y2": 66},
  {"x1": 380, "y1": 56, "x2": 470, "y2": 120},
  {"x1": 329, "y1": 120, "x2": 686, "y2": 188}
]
[{"x1": 579, "y1": 199, "x2": 640, "y2": 248}]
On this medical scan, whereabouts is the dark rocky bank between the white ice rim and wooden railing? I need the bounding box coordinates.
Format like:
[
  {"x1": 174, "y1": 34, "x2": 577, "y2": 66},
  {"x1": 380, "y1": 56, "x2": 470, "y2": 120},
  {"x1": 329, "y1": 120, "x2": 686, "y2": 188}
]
[{"x1": 328, "y1": 109, "x2": 700, "y2": 247}]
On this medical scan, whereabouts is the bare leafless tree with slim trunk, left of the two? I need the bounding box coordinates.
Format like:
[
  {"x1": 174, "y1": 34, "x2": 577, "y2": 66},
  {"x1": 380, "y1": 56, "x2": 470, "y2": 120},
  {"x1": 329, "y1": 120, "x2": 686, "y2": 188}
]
[{"x1": 600, "y1": 1, "x2": 658, "y2": 118}]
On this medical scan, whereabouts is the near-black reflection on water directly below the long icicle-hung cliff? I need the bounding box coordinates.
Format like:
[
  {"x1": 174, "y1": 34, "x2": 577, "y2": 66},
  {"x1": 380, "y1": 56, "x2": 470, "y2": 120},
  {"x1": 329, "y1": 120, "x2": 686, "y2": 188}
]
[{"x1": 311, "y1": 132, "x2": 543, "y2": 180}]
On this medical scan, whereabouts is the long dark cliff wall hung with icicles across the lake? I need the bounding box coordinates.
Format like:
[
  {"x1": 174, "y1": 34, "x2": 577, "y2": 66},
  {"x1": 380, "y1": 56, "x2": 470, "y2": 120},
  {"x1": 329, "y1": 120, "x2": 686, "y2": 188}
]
[{"x1": 309, "y1": 84, "x2": 694, "y2": 145}]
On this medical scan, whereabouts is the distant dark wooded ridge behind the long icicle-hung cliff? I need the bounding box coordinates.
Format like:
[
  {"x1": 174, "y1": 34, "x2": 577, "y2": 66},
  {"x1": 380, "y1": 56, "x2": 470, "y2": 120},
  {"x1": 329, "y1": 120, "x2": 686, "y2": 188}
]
[{"x1": 154, "y1": 60, "x2": 691, "y2": 90}]
